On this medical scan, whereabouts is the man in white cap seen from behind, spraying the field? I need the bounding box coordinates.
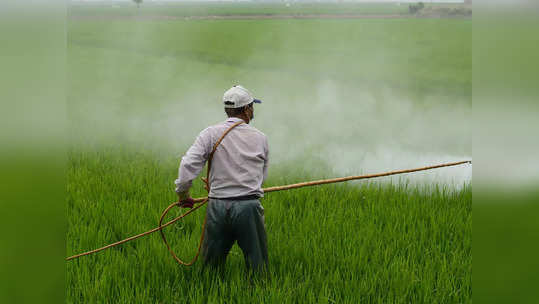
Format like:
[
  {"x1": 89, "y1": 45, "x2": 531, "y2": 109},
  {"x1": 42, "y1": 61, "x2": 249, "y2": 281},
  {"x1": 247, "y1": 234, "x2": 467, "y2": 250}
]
[{"x1": 175, "y1": 85, "x2": 268, "y2": 271}]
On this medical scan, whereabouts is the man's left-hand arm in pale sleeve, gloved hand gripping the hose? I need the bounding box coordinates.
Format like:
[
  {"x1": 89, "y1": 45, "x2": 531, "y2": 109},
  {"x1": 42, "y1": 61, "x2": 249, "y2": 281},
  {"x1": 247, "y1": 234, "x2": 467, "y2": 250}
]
[{"x1": 175, "y1": 129, "x2": 211, "y2": 201}]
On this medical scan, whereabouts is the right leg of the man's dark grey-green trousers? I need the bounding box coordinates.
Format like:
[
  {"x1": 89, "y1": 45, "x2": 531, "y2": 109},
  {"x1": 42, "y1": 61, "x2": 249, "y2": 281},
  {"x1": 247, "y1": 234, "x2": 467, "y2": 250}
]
[{"x1": 233, "y1": 200, "x2": 268, "y2": 271}]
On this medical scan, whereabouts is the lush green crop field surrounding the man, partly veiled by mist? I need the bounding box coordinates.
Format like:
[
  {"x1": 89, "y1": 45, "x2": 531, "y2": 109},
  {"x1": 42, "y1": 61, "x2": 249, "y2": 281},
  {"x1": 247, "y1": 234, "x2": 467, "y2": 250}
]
[{"x1": 66, "y1": 2, "x2": 472, "y2": 303}]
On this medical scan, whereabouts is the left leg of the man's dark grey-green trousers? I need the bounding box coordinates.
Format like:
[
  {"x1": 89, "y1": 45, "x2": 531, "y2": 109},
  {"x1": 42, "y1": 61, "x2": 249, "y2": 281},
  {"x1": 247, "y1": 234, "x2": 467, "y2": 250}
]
[{"x1": 202, "y1": 199, "x2": 234, "y2": 267}]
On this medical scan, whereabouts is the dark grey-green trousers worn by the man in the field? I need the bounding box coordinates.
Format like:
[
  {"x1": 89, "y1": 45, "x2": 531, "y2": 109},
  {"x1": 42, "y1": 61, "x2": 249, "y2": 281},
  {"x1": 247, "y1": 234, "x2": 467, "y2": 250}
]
[{"x1": 202, "y1": 198, "x2": 268, "y2": 271}]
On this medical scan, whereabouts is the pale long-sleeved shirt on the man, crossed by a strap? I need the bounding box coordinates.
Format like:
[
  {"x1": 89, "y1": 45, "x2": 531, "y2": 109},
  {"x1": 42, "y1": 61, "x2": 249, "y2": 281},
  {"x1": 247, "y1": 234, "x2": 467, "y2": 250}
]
[{"x1": 175, "y1": 117, "x2": 269, "y2": 198}]
